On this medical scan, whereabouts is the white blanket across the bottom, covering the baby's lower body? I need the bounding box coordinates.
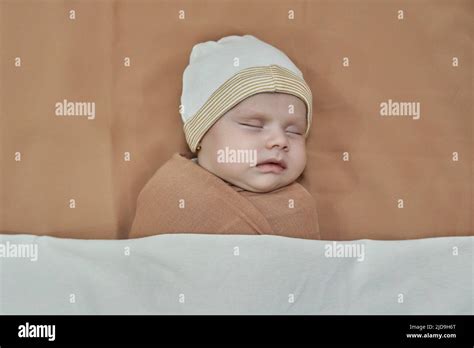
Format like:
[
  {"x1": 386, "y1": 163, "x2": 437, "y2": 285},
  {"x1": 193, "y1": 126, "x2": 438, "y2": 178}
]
[{"x1": 0, "y1": 234, "x2": 474, "y2": 314}]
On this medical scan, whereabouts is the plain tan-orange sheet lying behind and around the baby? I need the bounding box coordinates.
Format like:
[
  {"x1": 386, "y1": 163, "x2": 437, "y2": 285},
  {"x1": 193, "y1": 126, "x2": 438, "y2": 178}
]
[{"x1": 0, "y1": 0, "x2": 474, "y2": 240}]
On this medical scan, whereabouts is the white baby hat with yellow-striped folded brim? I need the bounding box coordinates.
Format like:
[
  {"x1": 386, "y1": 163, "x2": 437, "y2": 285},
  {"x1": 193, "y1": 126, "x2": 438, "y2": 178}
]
[{"x1": 181, "y1": 35, "x2": 312, "y2": 152}]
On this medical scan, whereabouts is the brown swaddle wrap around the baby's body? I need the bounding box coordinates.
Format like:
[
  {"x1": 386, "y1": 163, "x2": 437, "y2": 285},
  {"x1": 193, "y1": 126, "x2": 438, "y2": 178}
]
[{"x1": 129, "y1": 153, "x2": 320, "y2": 239}]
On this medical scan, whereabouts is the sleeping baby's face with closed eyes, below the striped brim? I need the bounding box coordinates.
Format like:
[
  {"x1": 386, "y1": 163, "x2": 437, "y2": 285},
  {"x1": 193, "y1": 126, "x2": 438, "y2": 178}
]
[{"x1": 198, "y1": 93, "x2": 307, "y2": 192}]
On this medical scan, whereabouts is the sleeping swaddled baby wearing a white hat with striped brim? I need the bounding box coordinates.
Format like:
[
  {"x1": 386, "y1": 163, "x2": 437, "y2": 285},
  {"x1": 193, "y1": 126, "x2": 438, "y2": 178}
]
[{"x1": 129, "y1": 35, "x2": 320, "y2": 239}]
